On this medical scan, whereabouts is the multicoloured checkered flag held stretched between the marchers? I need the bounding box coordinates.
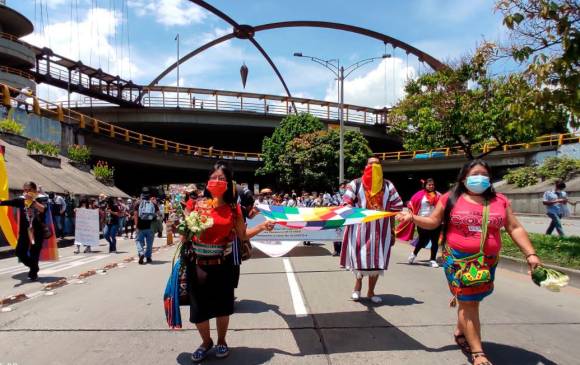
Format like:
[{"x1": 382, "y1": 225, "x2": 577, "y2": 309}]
[{"x1": 257, "y1": 204, "x2": 397, "y2": 230}]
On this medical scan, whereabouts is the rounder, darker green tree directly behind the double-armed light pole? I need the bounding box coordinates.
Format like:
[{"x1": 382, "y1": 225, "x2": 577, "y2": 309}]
[{"x1": 277, "y1": 130, "x2": 372, "y2": 190}]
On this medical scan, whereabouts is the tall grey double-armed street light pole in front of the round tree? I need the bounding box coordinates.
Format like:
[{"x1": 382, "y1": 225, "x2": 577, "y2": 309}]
[{"x1": 294, "y1": 52, "x2": 391, "y2": 184}]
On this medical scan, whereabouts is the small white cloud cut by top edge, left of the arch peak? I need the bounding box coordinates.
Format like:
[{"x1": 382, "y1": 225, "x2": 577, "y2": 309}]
[{"x1": 128, "y1": 0, "x2": 207, "y2": 26}]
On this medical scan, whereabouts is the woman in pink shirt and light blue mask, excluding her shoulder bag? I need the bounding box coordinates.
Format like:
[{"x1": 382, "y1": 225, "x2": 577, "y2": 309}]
[{"x1": 397, "y1": 160, "x2": 541, "y2": 365}]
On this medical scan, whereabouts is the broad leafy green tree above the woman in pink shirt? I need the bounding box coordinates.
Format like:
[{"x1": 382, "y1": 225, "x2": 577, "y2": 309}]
[{"x1": 390, "y1": 44, "x2": 565, "y2": 159}]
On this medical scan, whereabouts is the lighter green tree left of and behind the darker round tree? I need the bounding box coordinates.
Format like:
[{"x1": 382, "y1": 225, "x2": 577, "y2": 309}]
[{"x1": 256, "y1": 113, "x2": 324, "y2": 176}]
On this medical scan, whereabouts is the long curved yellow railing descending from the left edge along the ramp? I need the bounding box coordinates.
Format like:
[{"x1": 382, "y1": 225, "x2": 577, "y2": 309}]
[{"x1": 0, "y1": 84, "x2": 261, "y2": 161}]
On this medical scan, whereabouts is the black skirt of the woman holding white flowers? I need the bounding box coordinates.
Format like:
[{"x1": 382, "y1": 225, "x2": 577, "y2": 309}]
[{"x1": 187, "y1": 255, "x2": 235, "y2": 323}]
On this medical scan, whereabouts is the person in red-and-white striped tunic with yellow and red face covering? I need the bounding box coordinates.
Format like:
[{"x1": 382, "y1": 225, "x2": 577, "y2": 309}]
[{"x1": 340, "y1": 157, "x2": 403, "y2": 303}]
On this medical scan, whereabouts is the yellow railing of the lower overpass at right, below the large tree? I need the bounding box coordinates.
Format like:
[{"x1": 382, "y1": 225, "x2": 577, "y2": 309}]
[{"x1": 374, "y1": 132, "x2": 580, "y2": 161}]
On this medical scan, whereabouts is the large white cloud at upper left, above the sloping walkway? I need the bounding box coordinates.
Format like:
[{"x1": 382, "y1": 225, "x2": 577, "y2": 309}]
[{"x1": 24, "y1": 8, "x2": 143, "y2": 79}]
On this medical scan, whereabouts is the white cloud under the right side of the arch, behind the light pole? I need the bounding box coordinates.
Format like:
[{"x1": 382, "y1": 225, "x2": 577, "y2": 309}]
[{"x1": 325, "y1": 57, "x2": 416, "y2": 108}]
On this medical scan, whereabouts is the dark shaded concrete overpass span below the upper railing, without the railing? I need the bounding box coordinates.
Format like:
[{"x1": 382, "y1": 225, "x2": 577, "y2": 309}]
[{"x1": 77, "y1": 107, "x2": 402, "y2": 152}]
